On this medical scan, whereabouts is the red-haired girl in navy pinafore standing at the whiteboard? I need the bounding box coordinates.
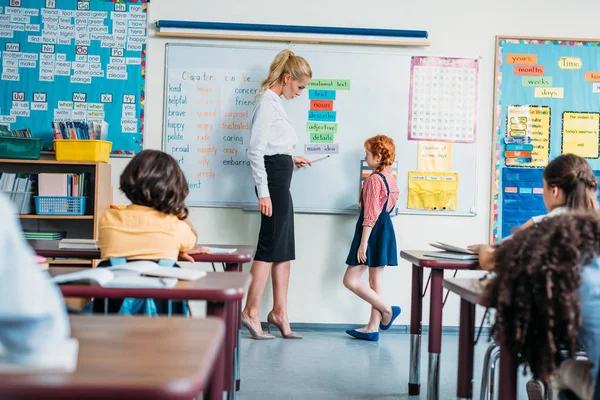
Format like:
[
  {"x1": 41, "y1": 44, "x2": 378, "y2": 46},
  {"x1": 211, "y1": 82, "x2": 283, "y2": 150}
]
[{"x1": 344, "y1": 135, "x2": 400, "y2": 341}]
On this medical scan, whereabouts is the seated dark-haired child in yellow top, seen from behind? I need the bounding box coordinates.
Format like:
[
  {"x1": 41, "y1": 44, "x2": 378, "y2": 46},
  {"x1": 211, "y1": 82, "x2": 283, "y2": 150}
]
[{"x1": 94, "y1": 150, "x2": 208, "y2": 315}]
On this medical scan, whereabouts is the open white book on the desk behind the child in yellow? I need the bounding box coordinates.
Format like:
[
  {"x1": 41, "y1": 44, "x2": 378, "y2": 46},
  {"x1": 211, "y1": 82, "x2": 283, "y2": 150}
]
[{"x1": 52, "y1": 261, "x2": 206, "y2": 288}]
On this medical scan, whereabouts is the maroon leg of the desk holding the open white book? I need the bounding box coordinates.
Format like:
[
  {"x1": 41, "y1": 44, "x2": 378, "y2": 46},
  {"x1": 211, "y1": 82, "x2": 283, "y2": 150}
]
[{"x1": 207, "y1": 302, "x2": 237, "y2": 400}]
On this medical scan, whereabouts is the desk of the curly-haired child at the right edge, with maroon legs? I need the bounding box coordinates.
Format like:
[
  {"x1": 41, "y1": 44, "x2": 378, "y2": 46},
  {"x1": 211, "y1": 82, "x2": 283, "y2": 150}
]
[{"x1": 444, "y1": 279, "x2": 518, "y2": 400}]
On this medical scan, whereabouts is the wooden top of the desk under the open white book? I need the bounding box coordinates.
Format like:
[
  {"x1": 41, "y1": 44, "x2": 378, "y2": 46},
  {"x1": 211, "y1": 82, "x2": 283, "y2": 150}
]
[{"x1": 48, "y1": 267, "x2": 252, "y2": 301}]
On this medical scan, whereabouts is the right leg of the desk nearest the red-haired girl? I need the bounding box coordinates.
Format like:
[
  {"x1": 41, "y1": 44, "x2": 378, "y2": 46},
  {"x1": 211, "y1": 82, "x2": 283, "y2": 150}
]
[{"x1": 427, "y1": 268, "x2": 444, "y2": 400}]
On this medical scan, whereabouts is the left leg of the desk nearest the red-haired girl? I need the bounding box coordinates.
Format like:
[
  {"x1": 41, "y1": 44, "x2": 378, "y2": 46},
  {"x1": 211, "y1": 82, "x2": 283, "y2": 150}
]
[{"x1": 408, "y1": 265, "x2": 423, "y2": 396}]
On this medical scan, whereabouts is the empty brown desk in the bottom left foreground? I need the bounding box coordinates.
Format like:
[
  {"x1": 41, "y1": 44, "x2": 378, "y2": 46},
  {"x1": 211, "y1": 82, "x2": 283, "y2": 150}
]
[{"x1": 0, "y1": 315, "x2": 225, "y2": 400}]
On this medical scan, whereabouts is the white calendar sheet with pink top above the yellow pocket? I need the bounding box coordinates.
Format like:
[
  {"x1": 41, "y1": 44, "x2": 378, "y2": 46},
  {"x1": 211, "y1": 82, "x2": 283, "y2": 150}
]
[{"x1": 408, "y1": 56, "x2": 479, "y2": 143}]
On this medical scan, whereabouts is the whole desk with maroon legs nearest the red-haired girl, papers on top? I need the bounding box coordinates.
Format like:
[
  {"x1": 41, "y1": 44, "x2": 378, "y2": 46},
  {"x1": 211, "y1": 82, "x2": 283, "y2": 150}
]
[{"x1": 400, "y1": 250, "x2": 479, "y2": 400}]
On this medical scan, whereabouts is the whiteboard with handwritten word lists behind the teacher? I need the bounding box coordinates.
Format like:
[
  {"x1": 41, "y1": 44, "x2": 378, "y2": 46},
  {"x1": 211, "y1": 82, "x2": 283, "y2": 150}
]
[{"x1": 163, "y1": 43, "x2": 477, "y2": 216}]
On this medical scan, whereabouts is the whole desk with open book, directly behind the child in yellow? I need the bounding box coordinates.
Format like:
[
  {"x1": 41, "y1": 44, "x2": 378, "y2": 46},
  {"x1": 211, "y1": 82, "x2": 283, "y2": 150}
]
[{"x1": 49, "y1": 267, "x2": 252, "y2": 397}]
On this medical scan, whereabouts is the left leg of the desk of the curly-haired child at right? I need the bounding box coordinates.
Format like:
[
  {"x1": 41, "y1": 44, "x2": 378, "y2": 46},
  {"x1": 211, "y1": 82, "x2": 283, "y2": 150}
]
[{"x1": 456, "y1": 299, "x2": 475, "y2": 400}]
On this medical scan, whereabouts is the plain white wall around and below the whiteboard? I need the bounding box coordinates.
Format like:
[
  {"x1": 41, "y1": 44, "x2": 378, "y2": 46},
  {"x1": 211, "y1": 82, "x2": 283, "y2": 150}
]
[{"x1": 111, "y1": 0, "x2": 599, "y2": 325}]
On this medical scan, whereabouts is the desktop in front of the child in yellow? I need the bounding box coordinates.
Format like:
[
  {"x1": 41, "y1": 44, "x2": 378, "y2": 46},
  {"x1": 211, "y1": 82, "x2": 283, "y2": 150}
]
[{"x1": 28, "y1": 239, "x2": 256, "y2": 263}]
